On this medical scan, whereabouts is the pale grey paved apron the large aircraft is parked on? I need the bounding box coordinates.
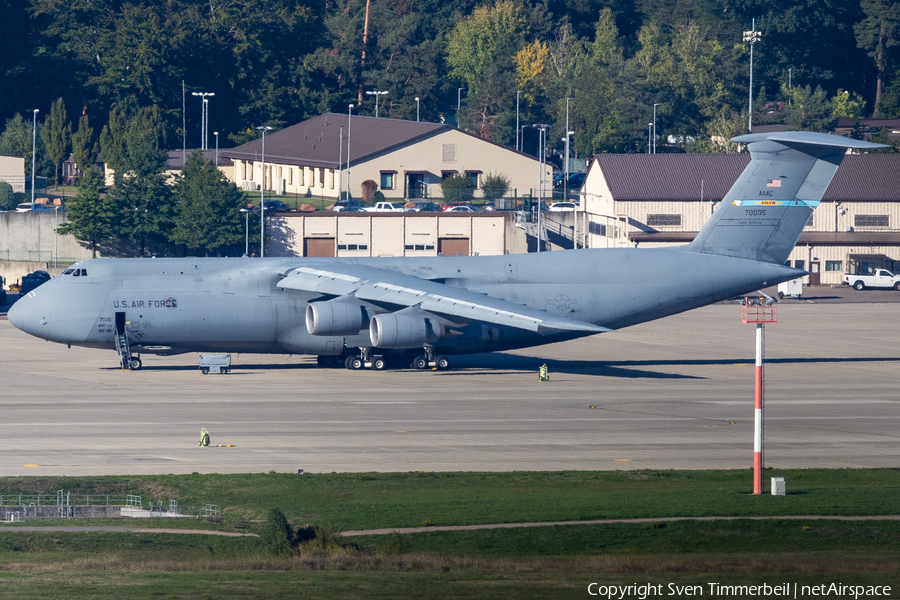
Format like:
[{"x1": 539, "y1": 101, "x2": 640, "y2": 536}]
[{"x1": 0, "y1": 292, "x2": 900, "y2": 475}]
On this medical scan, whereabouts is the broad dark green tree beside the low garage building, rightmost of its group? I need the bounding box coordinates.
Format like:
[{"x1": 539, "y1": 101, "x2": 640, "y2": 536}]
[{"x1": 169, "y1": 151, "x2": 245, "y2": 253}]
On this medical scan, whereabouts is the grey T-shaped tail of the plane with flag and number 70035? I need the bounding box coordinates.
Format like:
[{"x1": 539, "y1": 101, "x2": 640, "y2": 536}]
[{"x1": 685, "y1": 131, "x2": 885, "y2": 264}]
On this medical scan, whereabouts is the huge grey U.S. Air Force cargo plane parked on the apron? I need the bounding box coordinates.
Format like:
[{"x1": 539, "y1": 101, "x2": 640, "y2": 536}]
[{"x1": 8, "y1": 132, "x2": 882, "y2": 370}]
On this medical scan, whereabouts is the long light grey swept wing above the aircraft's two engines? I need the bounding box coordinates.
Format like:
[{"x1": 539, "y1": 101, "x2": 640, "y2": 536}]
[{"x1": 277, "y1": 265, "x2": 612, "y2": 335}]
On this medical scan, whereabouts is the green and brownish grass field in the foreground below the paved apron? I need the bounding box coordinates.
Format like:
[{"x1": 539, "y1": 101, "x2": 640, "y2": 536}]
[{"x1": 0, "y1": 470, "x2": 900, "y2": 598}]
